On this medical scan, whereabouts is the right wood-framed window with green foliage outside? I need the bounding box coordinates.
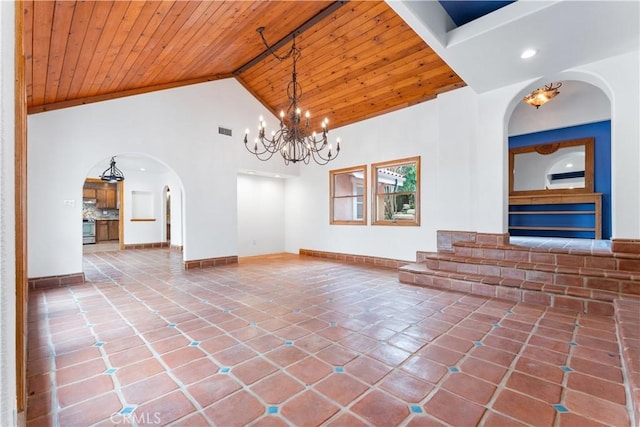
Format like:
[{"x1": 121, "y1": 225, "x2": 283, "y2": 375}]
[{"x1": 372, "y1": 157, "x2": 420, "y2": 225}]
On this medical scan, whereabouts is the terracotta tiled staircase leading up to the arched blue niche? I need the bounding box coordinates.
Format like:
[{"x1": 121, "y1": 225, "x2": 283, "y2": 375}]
[{"x1": 399, "y1": 241, "x2": 640, "y2": 316}]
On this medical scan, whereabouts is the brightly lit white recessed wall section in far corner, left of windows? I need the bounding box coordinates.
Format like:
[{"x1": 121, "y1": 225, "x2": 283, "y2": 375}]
[{"x1": 238, "y1": 174, "x2": 289, "y2": 257}]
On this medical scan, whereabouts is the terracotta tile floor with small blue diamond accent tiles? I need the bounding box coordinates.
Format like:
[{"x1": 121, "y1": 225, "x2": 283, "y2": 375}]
[{"x1": 27, "y1": 249, "x2": 631, "y2": 427}]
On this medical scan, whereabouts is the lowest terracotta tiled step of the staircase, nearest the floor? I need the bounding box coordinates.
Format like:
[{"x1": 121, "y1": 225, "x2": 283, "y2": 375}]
[{"x1": 399, "y1": 262, "x2": 619, "y2": 316}]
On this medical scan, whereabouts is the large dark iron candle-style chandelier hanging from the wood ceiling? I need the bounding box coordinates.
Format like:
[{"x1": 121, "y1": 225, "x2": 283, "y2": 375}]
[{"x1": 244, "y1": 27, "x2": 340, "y2": 165}]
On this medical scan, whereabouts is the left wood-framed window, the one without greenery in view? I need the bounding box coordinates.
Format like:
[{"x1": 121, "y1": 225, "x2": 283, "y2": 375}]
[{"x1": 329, "y1": 165, "x2": 367, "y2": 225}]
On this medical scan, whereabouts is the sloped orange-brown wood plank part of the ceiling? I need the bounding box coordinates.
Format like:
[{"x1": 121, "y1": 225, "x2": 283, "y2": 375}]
[{"x1": 23, "y1": 0, "x2": 465, "y2": 128}]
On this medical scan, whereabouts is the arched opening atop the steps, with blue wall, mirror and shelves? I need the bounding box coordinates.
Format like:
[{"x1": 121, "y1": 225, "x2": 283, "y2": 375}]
[{"x1": 507, "y1": 79, "x2": 612, "y2": 239}]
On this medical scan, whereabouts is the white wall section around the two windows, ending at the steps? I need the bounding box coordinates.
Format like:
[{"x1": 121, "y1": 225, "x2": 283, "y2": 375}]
[{"x1": 286, "y1": 102, "x2": 441, "y2": 260}]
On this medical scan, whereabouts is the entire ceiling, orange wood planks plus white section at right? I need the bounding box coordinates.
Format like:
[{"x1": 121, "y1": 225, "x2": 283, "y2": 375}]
[{"x1": 23, "y1": 0, "x2": 640, "y2": 132}]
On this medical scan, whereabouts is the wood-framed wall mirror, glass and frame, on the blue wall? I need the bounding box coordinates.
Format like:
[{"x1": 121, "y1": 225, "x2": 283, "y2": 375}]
[{"x1": 509, "y1": 138, "x2": 594, "y2": 196}]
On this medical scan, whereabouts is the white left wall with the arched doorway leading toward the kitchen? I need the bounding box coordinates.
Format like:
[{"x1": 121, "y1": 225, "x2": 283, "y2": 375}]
[{"x1": 28, "y1": 79, "x2": 292, "y2": 277}]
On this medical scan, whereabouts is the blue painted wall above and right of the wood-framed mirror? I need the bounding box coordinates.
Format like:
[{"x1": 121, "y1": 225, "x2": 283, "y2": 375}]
[{"x1": 509, "y1": 120, "x2": 611, "y2": 239}]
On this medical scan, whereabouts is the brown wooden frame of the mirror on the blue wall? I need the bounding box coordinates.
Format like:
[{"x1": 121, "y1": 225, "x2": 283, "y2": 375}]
[{"x1": 509, "y1": 137, "x2": 595, "y2": 196}]
